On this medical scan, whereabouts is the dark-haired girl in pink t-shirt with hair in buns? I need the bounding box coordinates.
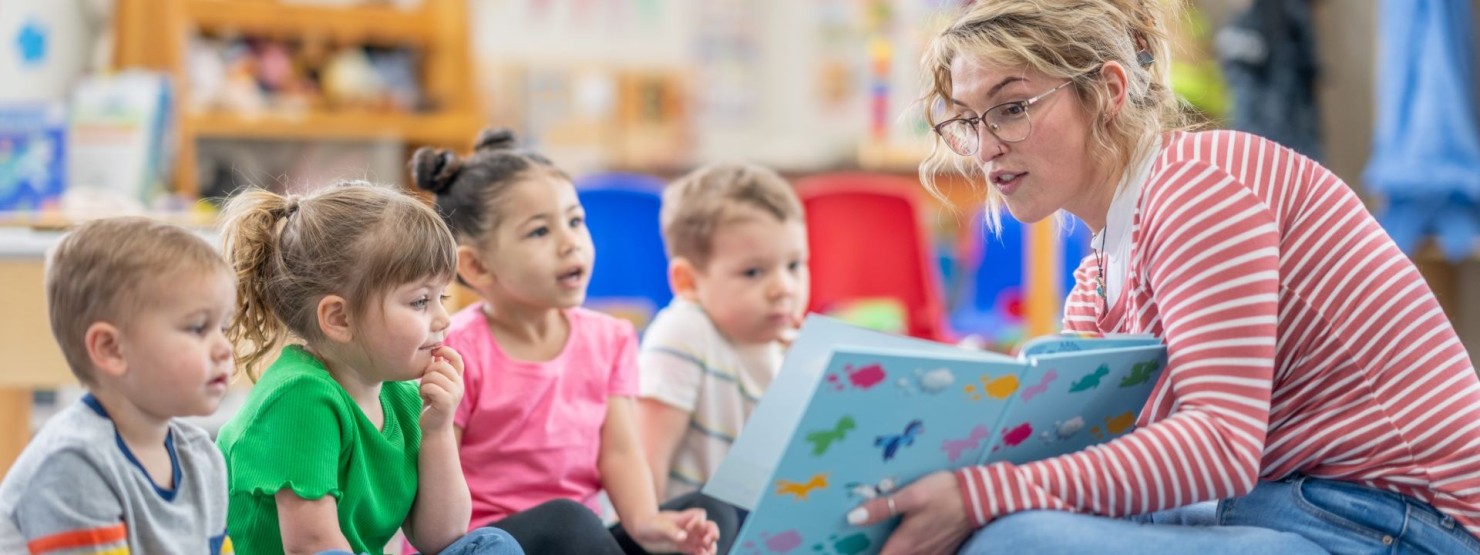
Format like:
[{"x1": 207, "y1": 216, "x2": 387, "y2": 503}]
[{"x1": 411, "y1": 130, "x2": 733, "y2": 554}]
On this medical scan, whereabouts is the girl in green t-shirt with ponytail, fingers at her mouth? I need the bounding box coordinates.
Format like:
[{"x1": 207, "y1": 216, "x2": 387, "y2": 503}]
[{"x1": 218, "y1": 182, "x2": 522, "y2": 555}]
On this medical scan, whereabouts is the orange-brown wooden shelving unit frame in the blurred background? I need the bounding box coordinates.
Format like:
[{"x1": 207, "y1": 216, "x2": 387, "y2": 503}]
[{"x1": 114, "y1": 0, "x2": 484, "y2": 198}]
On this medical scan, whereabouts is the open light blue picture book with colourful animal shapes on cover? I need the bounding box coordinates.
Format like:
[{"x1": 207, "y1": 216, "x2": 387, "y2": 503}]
[{"x1": 703, "y1": 315, "x2": 1166, "y2": 555}]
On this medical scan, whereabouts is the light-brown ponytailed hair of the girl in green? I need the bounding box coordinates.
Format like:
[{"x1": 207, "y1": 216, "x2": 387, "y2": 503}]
[{"x1": 223, "y1": 181, "x2": 457, "y2": 382}]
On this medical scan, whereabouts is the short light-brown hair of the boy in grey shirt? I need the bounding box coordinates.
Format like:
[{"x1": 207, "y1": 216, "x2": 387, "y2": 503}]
[{"x1": 46, "y1": 216, "x2": 229, "y2": 383}]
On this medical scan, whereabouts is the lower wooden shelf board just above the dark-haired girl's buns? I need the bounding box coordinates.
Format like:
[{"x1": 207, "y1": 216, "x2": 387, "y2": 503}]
[{"x1": 186, "y1": 112, "x2": 482, "y2": 145}]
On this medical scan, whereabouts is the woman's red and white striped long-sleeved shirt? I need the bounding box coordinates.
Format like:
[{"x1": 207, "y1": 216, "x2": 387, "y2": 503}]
[{"x1": 958, "y1": 132, "x2": 1480, "y2": 534}]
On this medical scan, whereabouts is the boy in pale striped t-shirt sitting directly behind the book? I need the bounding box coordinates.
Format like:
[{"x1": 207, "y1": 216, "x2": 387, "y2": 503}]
[{"x1": 638, "y1": 164, "x2": 808, "y2": 499}]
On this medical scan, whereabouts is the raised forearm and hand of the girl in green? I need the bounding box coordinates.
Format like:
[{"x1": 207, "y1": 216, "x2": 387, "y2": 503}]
[{"x1": 404, "y1": 346, "x2": 472, "y2": 554}]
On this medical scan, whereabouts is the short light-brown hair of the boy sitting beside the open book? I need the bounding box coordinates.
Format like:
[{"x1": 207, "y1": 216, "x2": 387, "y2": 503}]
[{"x1": 659, "y1": 164, "x2": 802, "y2": 269}]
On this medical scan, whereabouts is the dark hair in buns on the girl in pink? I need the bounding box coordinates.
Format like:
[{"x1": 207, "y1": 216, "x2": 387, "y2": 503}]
[{"x1": 410, "y1": 129, "x2": 570, "y2": 250}]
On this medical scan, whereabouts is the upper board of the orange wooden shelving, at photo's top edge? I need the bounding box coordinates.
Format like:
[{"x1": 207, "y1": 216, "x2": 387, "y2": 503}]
[{"x1": 185, "y1": 0, "x2": 437, "y2": 44}]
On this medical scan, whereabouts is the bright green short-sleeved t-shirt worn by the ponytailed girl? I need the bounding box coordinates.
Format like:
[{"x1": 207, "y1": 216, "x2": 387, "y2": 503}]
[{"x1": 216, "y1": 345, "x2": 422, "y2": 554}]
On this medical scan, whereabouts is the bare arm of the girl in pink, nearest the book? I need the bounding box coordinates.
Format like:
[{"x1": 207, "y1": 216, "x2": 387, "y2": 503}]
[{"x1": 596, "y1": 397, "x2": 719, "y2": 555}]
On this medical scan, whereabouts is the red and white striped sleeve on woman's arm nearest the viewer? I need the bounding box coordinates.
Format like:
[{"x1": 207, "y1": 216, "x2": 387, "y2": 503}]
[{"x1": 958, "y1": 160, "x2": 1279, "y2": 525}]
